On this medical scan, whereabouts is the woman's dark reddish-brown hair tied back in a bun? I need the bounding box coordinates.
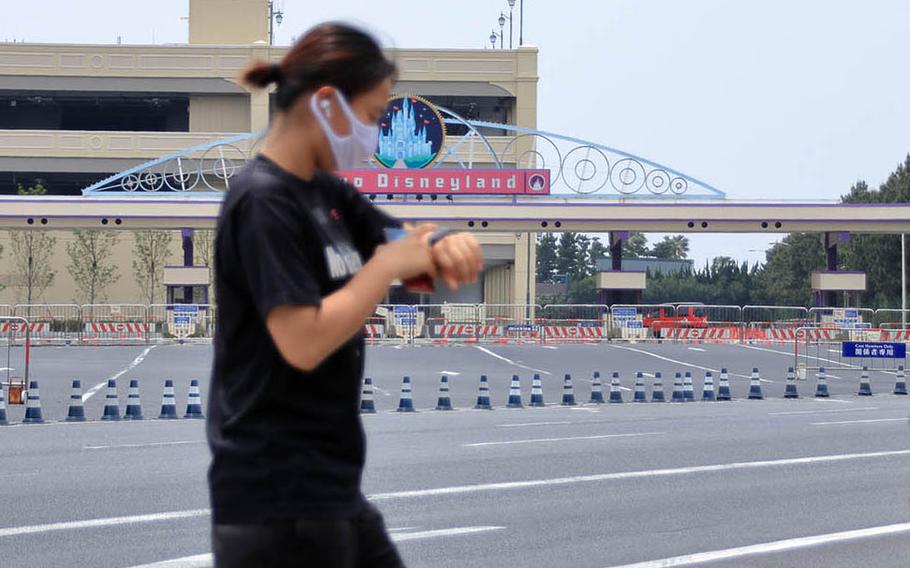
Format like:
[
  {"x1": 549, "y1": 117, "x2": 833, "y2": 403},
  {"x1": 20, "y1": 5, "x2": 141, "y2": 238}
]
[{"x1": 242, "y1": 22, "x2": 396, "y2": 110}]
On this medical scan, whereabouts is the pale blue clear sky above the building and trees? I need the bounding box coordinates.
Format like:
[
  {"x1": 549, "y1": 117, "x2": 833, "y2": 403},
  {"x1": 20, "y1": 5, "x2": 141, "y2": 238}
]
[{"x1": 0, "y1": 0, "x2": 910, "y2": 265}]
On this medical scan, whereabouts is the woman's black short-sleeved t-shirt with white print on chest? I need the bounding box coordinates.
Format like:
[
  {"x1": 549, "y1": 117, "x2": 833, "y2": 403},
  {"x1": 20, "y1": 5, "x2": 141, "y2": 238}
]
[{"x1": 208, "y1": 156, "x2": 397, "y2": 524}]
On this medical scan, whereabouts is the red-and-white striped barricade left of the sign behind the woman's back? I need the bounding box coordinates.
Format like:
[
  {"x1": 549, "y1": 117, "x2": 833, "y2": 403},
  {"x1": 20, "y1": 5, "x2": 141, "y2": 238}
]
[{"x1": 82, "y1": 304, "x2": 156, "y2": 345}]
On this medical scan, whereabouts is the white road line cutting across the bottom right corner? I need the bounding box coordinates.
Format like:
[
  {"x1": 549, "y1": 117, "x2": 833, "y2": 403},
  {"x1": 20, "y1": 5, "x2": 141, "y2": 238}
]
[{"x1": 612, "y1": 523, "x2": 910, "y2": 568}]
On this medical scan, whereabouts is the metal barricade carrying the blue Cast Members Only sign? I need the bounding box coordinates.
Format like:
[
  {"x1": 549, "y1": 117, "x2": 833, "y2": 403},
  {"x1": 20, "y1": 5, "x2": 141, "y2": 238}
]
[{"x1": 794, "y1": 326, "x2": 907, "y2": 379}]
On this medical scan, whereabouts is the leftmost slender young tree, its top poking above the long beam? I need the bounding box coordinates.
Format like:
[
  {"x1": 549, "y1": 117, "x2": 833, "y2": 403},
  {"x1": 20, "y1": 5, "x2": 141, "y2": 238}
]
[{"x1": 9, "y1": 183, "x2": 57, "y2": 304}]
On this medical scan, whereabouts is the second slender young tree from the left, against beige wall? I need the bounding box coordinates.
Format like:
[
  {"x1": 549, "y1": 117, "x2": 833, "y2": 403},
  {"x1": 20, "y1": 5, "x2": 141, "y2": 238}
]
[{"x1": 66, "y1": 230, "x2": 120, "y2": 304}]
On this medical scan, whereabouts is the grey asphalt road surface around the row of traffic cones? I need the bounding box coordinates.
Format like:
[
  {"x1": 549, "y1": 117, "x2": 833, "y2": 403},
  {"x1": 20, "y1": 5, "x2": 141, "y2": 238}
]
[{"x1": 0, "y1": 344, "x2": 910, "y2": 568}]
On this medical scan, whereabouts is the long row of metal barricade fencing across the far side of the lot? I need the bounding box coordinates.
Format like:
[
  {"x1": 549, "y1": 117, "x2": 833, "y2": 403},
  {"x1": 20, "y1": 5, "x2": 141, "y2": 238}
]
[{"x1": 0, "y1": 303, "x2": 910, "y2": 346}]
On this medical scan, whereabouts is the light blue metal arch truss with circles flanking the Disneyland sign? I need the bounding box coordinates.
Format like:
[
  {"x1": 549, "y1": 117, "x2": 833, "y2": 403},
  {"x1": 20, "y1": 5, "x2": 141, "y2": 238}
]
[{"x1": 82, "y1": 107, "x2": 726, "y2": 199}]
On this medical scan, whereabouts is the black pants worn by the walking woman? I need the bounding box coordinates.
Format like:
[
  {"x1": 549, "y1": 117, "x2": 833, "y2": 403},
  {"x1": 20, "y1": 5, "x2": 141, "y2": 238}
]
[{"x1": 212, "y1": 503, "x2": 404, "y2": 568}]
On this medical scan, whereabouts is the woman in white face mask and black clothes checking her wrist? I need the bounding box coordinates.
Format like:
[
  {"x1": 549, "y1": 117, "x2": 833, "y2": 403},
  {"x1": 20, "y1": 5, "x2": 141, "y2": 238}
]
[{"x1": 208, "y1": 24, "x2": 482, "y2": 568}]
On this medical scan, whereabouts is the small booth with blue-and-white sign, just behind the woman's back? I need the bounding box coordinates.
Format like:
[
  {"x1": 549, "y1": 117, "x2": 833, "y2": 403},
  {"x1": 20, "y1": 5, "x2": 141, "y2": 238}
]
[{"x1": 164, "y1": 266, "x2": 212, "y2": 339}]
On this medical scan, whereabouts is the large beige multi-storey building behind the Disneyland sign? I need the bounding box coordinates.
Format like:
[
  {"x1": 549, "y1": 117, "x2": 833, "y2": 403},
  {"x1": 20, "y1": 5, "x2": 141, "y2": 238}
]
[{"x1": 0, "y1": 0, "x2": 538, "y2": 304}]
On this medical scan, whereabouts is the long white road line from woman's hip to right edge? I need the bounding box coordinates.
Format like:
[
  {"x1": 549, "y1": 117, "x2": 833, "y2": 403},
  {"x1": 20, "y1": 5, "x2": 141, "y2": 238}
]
[{"x1": 368, "y1": 450, "x2": 910, "y2": 501}]
